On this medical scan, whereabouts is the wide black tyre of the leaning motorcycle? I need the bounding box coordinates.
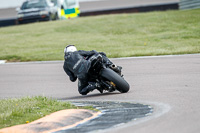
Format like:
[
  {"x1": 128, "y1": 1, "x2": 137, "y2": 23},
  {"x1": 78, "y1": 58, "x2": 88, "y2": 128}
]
[{"x1": 100, "y1": 68, "x2": 130, "y2": 93}]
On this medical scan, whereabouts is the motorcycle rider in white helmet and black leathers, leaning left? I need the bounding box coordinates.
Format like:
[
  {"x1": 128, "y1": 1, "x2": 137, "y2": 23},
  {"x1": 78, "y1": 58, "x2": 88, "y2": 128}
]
[{"x1": 63, "y1": 45, "x2": 121, "y2": 95}]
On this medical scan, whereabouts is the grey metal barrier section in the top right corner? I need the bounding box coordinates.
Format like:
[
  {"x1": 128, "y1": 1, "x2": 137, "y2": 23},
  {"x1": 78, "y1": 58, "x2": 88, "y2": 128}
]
[{"x1": 179, "y1": 0, "x2": 200, "y2": 10}]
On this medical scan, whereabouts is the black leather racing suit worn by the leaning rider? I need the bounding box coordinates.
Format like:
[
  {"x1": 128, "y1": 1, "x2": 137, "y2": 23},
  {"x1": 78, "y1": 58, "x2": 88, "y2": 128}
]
[{"x1": 63, "y1": 50, "x2": 109, "y2": 95}]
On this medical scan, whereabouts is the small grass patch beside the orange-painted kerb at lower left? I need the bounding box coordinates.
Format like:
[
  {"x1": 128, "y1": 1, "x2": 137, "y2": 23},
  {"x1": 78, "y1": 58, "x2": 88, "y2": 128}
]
[{"x1": 0, "y1": 96, "x2": 94, "y2": 129}]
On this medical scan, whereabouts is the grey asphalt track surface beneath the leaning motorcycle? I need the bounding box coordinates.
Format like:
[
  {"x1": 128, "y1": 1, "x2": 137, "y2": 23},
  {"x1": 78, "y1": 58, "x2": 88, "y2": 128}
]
[{"x1": 0, "y1": 54, "x2": 200, "y2": 133}]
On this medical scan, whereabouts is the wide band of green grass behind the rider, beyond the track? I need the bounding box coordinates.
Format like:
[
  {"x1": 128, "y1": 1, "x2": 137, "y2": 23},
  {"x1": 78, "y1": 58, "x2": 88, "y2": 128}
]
[{"x1": 0, "y1": 9, "x2": 200, "y2": 61}]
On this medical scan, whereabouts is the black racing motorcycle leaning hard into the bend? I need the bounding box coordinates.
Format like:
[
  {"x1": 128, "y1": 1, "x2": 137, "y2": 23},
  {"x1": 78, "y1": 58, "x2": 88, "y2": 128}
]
[{"x1": 88, "y1": 54, "x2": 130, "y2": 93}]
